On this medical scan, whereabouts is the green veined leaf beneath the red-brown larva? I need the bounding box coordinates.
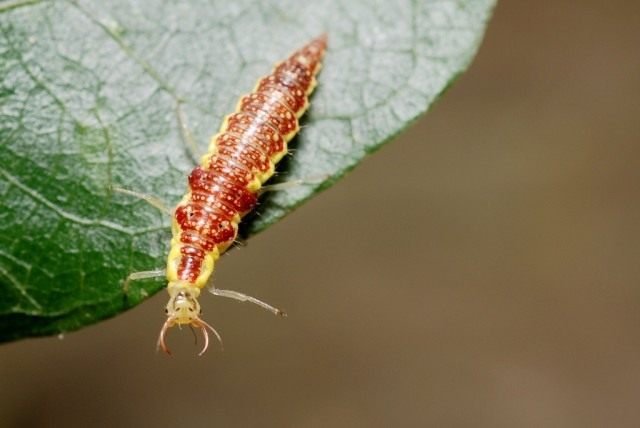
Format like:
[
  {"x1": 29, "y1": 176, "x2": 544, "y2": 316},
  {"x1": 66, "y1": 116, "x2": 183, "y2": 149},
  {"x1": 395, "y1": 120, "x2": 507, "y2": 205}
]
[{"x1": 0, "y1": 0, "x2": 494, "y2": 341}]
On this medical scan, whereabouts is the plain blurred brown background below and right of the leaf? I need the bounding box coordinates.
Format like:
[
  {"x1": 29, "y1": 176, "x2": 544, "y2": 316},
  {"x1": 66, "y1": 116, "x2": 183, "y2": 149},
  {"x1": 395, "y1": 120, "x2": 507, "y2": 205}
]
[{"x1": 0, "y1": 0, "x2": 640, "y2": 428}]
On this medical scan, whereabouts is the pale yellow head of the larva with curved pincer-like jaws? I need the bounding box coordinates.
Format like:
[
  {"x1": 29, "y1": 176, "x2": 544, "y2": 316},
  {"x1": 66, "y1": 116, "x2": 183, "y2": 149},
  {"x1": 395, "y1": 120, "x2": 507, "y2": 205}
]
[{"x1": 158, "y1": 282, "x2": 222, "y2": 355}]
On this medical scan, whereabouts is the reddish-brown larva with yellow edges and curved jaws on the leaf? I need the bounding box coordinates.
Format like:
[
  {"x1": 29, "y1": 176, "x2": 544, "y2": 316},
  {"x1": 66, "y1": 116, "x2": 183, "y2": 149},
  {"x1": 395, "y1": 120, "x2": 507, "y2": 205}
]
[{"x1": 123, "y1": 35, "x2": 327, "y2": 355}]
